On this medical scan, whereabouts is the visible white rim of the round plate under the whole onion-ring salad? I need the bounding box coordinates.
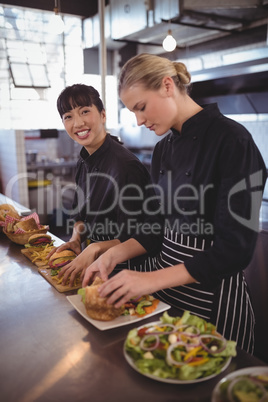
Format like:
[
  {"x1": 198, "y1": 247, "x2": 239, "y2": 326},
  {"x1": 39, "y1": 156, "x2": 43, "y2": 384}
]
[{"x1": 123, "y1": 321, "x2": 232, "y2": 384}]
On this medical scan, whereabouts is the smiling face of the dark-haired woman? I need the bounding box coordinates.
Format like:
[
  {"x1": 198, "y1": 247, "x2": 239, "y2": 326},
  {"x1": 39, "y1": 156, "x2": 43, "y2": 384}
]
[{"x1": 62, "y1": 105, "x2": 106, "y2": 154}]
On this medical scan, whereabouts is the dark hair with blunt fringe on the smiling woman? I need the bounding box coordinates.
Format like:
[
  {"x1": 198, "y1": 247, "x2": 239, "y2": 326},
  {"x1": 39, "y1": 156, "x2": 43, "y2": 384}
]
[{"x1": 57, "y1": 84, "x2": 104, "y2": 117}]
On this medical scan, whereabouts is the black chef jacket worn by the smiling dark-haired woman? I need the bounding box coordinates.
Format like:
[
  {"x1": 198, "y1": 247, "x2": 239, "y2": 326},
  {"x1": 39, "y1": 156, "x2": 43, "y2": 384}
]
[{"x1": 72, "y1": 134, "x2": 162, "y2": 254}]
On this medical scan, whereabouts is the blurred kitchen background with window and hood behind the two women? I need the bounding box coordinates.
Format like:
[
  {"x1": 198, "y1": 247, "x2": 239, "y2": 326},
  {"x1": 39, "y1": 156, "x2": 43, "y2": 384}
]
[{"x1": 0, "y1": 0, "x2": 268, "y2": 236}]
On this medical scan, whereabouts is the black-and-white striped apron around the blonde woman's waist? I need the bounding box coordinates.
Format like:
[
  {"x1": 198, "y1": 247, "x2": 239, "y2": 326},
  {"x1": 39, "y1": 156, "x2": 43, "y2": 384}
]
[{"x1": 154, "y1": 228, "x2": 255, "y2": 354}]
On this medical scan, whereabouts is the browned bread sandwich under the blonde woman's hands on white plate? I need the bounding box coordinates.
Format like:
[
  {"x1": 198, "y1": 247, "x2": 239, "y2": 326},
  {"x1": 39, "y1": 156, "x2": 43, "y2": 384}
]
[{"x1": 78, "y1": 278, "x2": 124, "y2": 321}]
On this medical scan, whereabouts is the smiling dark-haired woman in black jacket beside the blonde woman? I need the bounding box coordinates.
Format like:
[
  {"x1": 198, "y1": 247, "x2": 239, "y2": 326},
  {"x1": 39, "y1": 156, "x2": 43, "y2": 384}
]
[{"x1": 49, "y1": 84, "x2": 161, "y2": 286}]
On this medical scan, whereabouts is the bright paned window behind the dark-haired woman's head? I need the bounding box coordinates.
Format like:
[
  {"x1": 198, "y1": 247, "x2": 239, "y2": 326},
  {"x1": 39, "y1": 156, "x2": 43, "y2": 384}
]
[{"x1": 0, "y1": 4, "x2": 83, "y2": 130}]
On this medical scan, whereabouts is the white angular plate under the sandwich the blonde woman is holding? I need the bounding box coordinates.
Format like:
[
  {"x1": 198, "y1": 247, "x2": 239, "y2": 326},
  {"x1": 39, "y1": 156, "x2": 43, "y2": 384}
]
[{"x1": 66, "y1": 295, "x2": 170, "y2": 331}]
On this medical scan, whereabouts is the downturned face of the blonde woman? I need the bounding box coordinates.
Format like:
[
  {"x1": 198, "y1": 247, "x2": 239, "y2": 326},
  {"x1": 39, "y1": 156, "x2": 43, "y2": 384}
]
[{"x1": 120, "y1": 79, "x2": 177, "y2": 136}]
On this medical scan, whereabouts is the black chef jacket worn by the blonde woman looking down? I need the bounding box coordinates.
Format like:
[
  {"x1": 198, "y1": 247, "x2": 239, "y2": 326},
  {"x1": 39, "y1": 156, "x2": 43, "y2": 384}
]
[{"x1": 152, "y1": 104, "x2": 267, "y2": 288}]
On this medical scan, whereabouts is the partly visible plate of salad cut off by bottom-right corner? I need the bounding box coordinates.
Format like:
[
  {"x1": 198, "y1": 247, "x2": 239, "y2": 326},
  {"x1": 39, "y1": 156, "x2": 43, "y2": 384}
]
[{"x1": 212, "y1": 366, "x2": 268, "y2": 402}]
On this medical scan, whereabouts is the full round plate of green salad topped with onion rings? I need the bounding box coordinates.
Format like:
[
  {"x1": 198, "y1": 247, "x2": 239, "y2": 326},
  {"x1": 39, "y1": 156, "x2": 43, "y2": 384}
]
[{"x1": 124, "y1": 311, "x2": 236, "y2": 384}]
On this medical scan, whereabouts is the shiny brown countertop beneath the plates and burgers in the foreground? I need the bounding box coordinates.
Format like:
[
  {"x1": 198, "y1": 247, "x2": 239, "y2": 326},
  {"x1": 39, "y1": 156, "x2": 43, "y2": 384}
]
[{"x1": 0, "y1": 233, "x2": 265, "y2": 402}]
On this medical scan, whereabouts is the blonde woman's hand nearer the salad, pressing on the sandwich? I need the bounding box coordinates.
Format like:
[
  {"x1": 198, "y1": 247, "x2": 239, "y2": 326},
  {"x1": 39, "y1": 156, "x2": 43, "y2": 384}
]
[{"x1": 99, "y1": 269, "x2": 153, "y2": 307}]
